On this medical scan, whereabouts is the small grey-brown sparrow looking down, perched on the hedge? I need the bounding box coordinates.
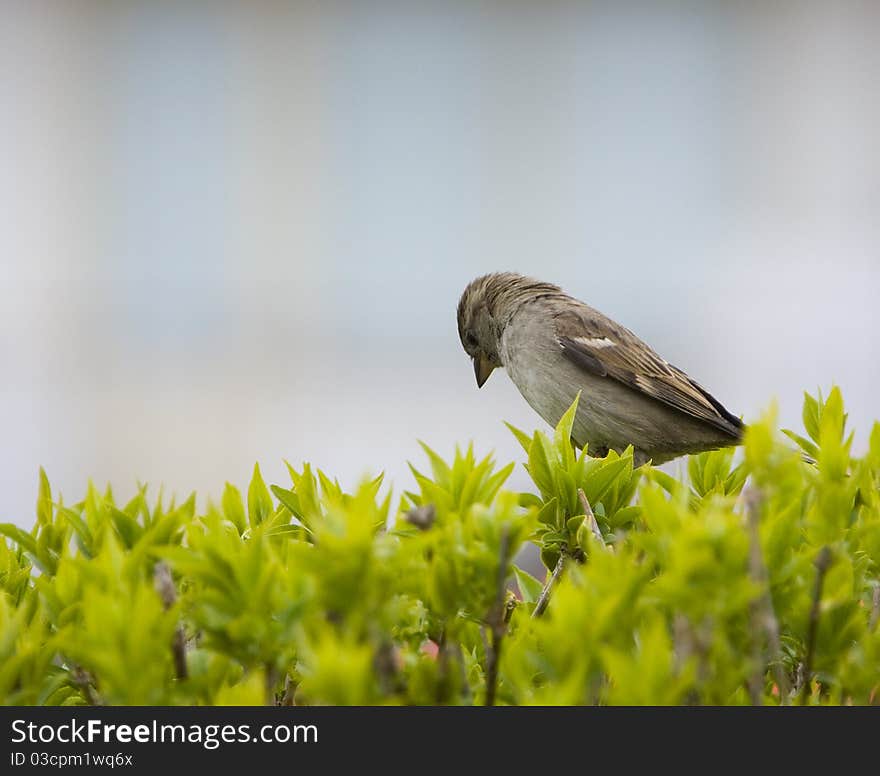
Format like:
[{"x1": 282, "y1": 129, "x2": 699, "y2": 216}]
[{"x1": 457, "y1": 272, "x2": 744, "y2": 466}]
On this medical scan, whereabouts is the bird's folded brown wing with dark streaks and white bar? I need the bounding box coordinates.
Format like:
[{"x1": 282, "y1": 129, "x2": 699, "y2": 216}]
[{"x1": 554, "y1": 306, "x2": 743, "y2": 438}]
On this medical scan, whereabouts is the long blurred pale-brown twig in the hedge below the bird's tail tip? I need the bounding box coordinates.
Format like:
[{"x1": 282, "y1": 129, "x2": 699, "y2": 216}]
[{"x1": 743, "y1": 487, "x2": 791, "y2": 706}]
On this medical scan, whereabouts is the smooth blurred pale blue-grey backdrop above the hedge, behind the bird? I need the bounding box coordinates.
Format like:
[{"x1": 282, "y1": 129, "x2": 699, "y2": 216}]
[{"x1": 0, "y1": 0, "x2": 880, "y2": 524}]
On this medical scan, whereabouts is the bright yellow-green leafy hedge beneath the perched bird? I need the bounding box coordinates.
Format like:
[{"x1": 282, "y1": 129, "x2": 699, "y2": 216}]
[{"x1": 0, "y1": 389, "x2": 880, "y2": 704}]
